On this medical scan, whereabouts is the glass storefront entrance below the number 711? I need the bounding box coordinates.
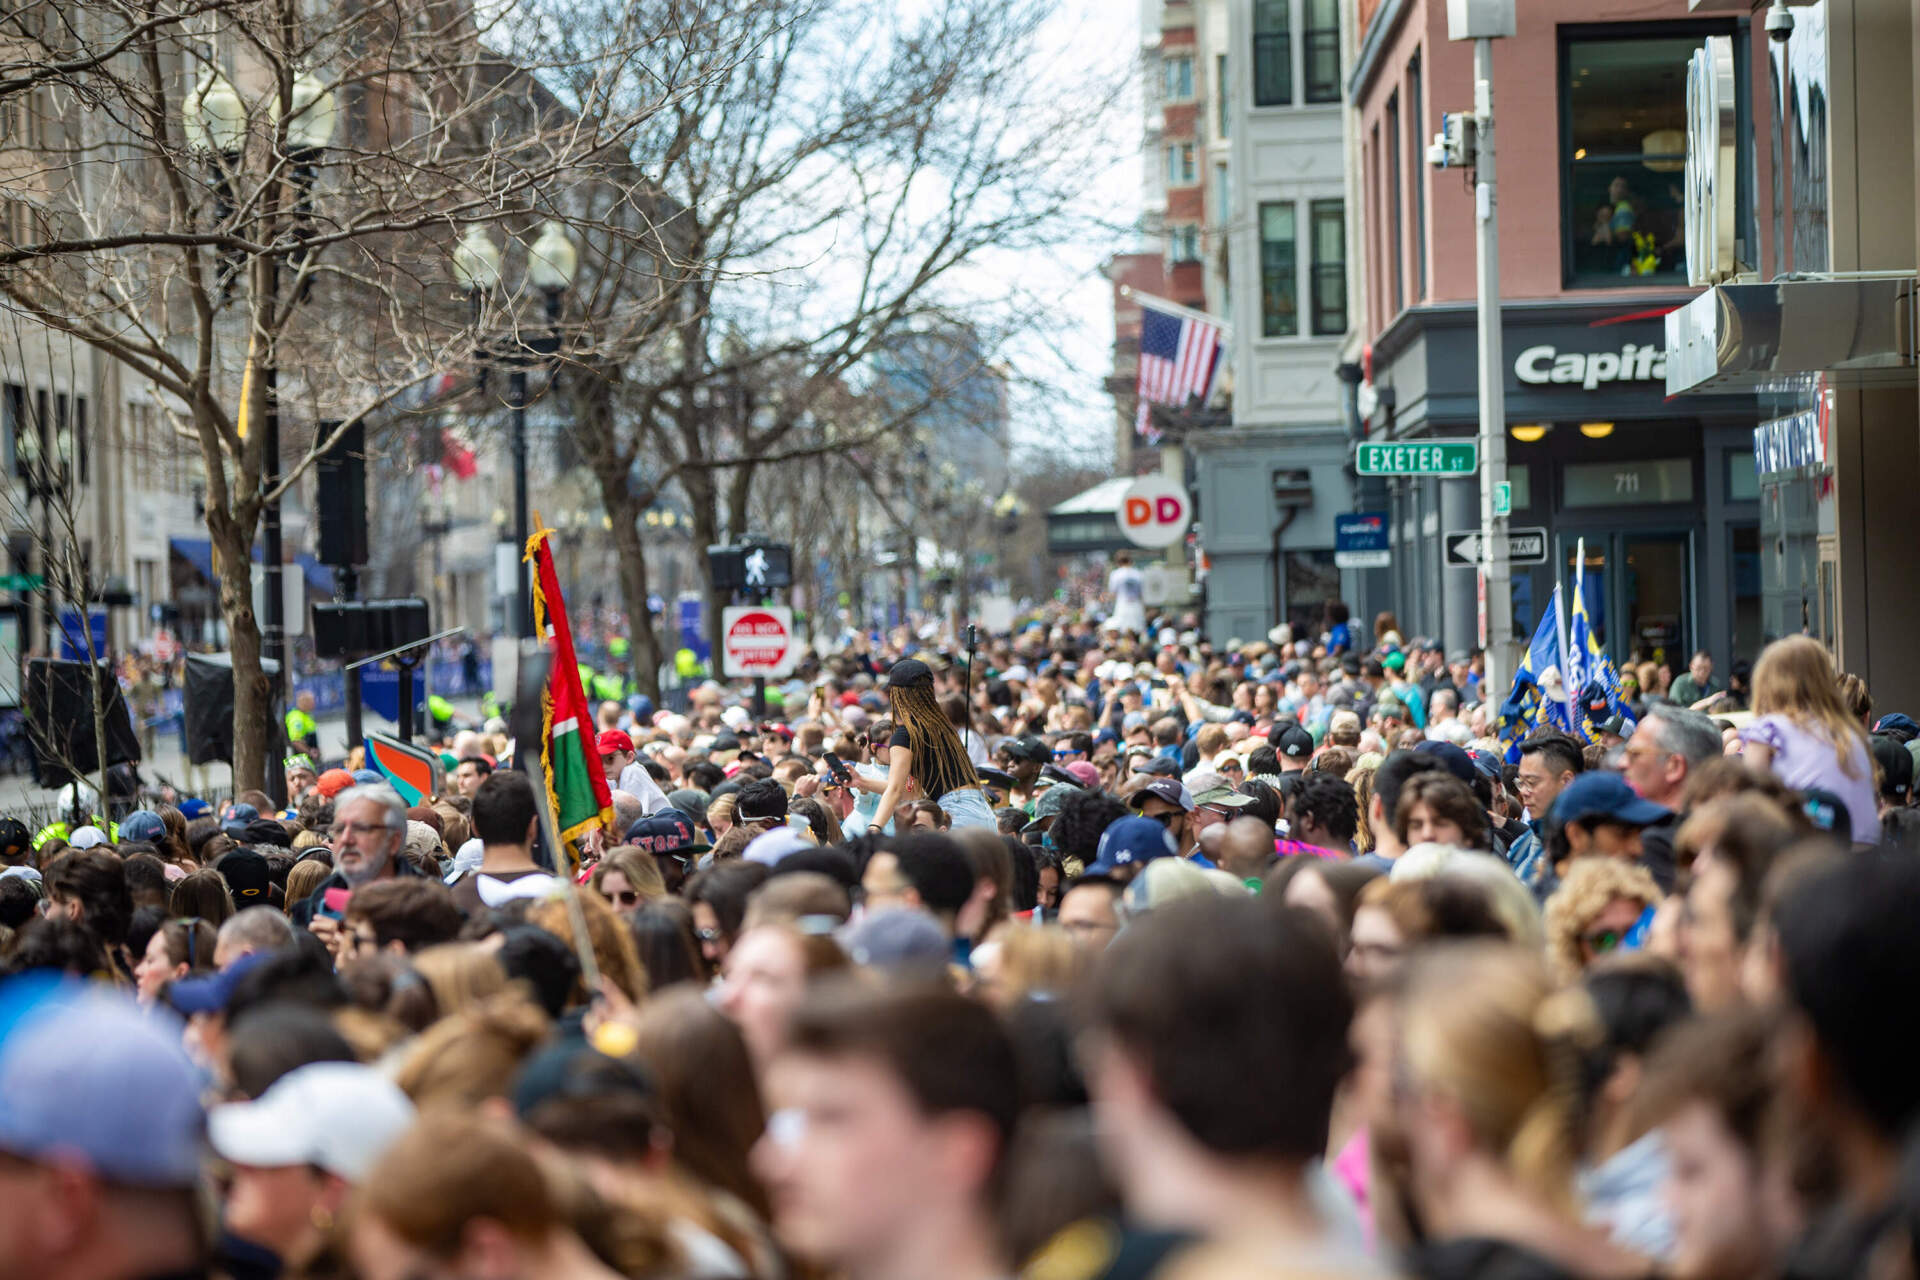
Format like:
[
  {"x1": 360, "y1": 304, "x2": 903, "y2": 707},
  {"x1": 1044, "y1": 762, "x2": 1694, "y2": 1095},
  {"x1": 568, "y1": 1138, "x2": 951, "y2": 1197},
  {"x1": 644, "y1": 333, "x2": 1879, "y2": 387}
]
[{"x1": 1555, "y1": 526, "x2": 1695, "y2": 672}]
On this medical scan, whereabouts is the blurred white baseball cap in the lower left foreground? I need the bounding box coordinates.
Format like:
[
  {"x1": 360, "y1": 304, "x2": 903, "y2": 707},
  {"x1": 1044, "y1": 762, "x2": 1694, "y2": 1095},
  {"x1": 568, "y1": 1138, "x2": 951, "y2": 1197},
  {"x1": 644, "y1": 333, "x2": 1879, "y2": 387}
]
[{"x1": 207, "y1": 1063, "x2": 413, "y2": 1184}]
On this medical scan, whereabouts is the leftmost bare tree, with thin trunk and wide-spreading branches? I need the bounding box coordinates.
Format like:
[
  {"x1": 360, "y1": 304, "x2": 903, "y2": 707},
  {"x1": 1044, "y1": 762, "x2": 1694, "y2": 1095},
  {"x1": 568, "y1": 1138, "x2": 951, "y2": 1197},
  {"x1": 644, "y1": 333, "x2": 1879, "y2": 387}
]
[{"x1": 0, "y1": 0, "x2": 710, "y2": 787}]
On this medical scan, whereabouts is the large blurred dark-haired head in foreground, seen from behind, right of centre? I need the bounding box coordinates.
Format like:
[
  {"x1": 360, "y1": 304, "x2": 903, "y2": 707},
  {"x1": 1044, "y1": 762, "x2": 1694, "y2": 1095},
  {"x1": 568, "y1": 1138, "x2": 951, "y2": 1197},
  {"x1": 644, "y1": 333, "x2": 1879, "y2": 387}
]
[{"x1": 1083, "y1": 894, "x2": 1354, "y2": 1197}]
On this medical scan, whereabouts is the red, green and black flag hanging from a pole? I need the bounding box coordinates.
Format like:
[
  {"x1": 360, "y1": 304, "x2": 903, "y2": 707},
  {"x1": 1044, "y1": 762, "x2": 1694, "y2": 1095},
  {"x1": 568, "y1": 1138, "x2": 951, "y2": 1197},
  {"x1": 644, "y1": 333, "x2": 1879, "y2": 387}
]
[{"x1": 526, "y1": 530, "x2": 612, "y2": 871}]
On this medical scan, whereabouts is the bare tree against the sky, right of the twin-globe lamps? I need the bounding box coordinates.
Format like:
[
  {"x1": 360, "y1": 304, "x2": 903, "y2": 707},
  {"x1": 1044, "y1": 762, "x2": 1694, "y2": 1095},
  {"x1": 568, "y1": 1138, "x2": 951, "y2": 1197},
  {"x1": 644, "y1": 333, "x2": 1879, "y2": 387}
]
[{"x1": 526, "y1": 0, "x2": 1121, "y2": 702}]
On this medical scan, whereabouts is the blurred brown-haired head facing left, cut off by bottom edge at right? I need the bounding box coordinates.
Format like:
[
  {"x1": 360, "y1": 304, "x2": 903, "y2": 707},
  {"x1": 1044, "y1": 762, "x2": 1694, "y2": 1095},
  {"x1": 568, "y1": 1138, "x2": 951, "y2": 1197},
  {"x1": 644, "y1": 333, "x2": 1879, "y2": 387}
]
[{"x1": 1640, "y1": 1009, "x2": 1788, "y2": 1280}]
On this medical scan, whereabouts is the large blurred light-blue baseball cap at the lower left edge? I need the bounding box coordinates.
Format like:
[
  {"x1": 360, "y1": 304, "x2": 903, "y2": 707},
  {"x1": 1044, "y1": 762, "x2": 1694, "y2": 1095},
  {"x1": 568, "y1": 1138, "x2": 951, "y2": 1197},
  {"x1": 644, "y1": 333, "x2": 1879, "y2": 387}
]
[{"x1": 0, "y1": 977, "x2": 205, "y2": 1188}]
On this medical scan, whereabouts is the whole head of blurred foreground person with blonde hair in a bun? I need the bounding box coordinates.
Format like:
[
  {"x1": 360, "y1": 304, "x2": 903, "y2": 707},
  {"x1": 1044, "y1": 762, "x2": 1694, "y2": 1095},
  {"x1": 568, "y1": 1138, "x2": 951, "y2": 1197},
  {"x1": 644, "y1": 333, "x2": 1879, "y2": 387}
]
[{"x1": 1394, "y1": 942, "x2": 1603, "y2": 1211}]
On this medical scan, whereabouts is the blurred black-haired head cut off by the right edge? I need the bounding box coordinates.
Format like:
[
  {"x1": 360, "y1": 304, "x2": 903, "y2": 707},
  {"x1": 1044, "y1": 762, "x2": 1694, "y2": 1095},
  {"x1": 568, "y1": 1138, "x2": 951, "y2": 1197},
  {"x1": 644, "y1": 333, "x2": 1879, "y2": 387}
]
[{"x1": 1755, "y1": 852, "x2": 1920, "y2": 1159}]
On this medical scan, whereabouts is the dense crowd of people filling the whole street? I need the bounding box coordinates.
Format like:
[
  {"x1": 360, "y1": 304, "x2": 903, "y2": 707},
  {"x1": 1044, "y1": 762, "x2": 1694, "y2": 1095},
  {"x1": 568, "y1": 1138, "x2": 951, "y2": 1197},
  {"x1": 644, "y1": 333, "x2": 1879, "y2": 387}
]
[{"x1": 0, "y1": 606, "x2": 1920, "y2": 1280}]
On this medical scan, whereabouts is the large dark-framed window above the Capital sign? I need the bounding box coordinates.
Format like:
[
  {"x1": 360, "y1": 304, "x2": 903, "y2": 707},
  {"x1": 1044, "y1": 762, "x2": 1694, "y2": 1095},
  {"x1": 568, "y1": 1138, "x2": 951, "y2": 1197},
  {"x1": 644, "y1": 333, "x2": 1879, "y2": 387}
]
[{"x1": 1561, "y1": 35, "x2": 1701, "y2": 286}]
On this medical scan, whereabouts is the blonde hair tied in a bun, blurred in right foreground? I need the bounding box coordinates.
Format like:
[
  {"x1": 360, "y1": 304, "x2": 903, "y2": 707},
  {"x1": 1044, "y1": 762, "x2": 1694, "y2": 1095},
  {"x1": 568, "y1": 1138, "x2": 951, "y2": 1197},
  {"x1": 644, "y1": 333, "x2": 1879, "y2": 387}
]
[{"x1": 1400, "y1": 942, "x2": 1603, "y2": 1213}]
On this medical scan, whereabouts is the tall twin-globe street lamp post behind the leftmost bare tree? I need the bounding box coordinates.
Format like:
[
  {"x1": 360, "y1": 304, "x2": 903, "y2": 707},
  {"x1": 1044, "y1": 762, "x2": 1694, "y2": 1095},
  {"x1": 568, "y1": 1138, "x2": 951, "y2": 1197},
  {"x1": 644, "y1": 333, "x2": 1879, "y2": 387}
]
[{"x1": 180, "y1": 71, "x2": 338, "y2": 804}]
